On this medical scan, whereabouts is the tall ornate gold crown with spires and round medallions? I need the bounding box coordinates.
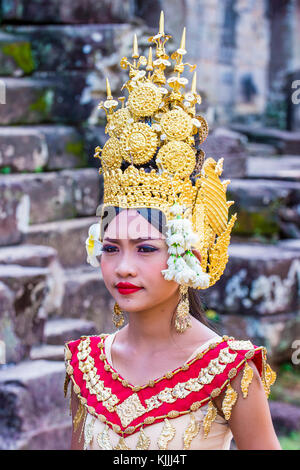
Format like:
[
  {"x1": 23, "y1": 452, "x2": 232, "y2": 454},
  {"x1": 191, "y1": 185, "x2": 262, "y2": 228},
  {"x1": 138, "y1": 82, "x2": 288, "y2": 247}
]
[{"x1": 95, "y1": 12, "x2": 237, "y2": 286}]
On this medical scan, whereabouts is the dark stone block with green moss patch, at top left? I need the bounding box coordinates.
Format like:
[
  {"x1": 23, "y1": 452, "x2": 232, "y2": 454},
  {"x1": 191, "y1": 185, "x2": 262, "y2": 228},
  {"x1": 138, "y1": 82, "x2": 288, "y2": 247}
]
[{"x1": 0, "y1": 24, "x2": 132, "y2": 76}]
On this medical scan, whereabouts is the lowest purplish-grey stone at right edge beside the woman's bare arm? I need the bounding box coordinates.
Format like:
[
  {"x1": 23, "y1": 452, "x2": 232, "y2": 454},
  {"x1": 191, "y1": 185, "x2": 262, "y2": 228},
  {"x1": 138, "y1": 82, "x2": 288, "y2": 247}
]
[{"x1": 269, "y1": 400, "x2": 300, "y2": 434}]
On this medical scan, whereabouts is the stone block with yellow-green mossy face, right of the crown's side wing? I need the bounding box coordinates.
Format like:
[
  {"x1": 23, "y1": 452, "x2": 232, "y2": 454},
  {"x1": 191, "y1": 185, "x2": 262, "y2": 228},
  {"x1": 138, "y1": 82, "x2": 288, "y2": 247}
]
[{"x1": 227, "y1": 179, "x2": 300, "y2": 239}]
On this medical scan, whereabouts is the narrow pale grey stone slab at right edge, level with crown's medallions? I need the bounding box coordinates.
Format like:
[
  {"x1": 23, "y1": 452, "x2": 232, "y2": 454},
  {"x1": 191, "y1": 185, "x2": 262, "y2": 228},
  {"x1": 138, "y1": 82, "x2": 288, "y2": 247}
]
[{"x1": 247, "y1": 156, "x2": 300, "y2": 181}]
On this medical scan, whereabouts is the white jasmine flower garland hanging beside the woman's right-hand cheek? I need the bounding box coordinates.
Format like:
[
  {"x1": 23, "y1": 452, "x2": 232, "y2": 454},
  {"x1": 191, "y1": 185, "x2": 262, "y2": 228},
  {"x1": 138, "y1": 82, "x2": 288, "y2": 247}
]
[{"x1": 161, "y1": 203, "x2": 210, "y2": 288}]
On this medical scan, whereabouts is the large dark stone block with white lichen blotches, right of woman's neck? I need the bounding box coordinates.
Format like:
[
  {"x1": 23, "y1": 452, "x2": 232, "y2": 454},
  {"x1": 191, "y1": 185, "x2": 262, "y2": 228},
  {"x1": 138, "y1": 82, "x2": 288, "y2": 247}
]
[{"x1": 201, "y1": 243, "x2": 300, "y2": 363}]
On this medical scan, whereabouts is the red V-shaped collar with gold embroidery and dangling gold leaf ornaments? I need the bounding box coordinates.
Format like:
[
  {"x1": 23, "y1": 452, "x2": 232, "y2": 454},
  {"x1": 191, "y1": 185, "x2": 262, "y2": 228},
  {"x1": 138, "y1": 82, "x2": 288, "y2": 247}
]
[{"x1": 65, "y1": 334, "x2": 276, "y2": 446}]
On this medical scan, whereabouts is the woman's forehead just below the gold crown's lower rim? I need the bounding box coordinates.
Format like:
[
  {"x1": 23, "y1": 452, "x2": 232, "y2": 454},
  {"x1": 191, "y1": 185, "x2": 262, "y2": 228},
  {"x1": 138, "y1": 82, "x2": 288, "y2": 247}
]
[{"x1": 104, "y1": 209, "x2": 165, "y2": 240}]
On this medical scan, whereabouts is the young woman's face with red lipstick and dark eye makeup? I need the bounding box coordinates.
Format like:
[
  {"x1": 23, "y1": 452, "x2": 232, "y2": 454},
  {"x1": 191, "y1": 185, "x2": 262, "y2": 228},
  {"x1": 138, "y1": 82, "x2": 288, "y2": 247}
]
[{"x1": 100, "y1": 209, "x2": 179, "y2": 312}]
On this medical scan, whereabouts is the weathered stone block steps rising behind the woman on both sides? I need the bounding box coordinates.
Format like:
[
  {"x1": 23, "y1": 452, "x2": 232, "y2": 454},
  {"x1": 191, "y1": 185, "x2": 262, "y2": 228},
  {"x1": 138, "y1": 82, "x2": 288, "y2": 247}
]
[{"x1": 0, "y1": 0, "x2": 300, "y2": 449}]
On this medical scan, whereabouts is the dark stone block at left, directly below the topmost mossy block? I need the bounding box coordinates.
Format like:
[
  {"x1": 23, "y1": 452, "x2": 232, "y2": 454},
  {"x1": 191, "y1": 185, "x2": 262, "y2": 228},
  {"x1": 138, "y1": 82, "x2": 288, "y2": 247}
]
[{"x1": 0, "y1": 72, "x2": 96, "y2": 125}]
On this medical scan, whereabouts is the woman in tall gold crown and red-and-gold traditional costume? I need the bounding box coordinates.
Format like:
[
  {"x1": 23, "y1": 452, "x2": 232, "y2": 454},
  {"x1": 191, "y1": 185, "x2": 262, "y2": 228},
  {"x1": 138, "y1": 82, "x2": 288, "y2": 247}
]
[{"x1": 65, "y1": 14, "x2": 280, "y2": 450}]
